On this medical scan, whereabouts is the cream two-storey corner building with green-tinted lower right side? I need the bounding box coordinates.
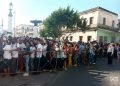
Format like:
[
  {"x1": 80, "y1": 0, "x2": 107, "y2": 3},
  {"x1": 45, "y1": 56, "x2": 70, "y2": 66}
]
[{"x1": 62, "y1": 7, "x2": 120, "y2": 42}]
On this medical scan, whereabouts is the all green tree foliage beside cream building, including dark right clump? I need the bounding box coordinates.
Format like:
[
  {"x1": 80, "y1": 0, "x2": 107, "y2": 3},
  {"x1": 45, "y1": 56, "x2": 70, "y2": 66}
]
[{"x1": 40, "y1": 6, "x2": 87, "y2": 38}]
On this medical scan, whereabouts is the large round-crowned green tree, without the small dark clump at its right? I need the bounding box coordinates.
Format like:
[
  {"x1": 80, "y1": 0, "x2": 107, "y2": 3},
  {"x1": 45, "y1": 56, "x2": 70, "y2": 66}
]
[{"x1": 40, "y1": 6, "x2": 77, "y2": 38}]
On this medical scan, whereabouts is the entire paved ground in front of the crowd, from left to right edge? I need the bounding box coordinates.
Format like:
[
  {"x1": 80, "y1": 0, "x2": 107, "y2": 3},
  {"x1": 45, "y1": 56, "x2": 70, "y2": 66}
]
[{"x1": 0, "y1": 58, "x2": 120, "y2": 86}]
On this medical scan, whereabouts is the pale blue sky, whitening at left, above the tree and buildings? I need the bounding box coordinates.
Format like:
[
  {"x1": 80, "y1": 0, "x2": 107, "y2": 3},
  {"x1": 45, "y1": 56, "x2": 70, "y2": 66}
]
[{"x1": 0, "y1": 0, "x2": 120, "y2": 29}]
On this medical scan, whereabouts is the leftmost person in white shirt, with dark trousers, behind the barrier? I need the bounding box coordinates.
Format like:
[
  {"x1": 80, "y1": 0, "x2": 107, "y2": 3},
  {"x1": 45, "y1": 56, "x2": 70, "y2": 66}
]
[{"x1": 3, "y1": 42, "x2": 12, "y2": 76}]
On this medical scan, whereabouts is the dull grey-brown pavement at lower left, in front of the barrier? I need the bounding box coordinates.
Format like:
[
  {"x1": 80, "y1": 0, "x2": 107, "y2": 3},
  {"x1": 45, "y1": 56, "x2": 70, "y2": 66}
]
[{"x1": 0, "y1": 72, "x2": 61, "y2": 86}]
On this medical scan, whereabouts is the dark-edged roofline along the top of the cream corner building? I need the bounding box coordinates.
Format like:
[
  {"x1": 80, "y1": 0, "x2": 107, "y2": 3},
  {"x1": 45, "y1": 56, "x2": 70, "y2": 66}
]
[{"x1": 80, "y1": 7, "x2": 118, "y2": 16}]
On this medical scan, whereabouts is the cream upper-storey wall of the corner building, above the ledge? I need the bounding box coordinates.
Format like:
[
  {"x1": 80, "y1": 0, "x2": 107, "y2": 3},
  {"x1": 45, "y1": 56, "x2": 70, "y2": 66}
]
[{"x1": 80, "y1": 9, "x2": 118, "y2": 28}]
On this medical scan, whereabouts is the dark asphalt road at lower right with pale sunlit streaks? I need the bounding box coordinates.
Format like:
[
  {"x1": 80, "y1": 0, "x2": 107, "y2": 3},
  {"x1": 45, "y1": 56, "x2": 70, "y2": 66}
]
[{"x1": 51, "y1": 58, "x2": 120, "y2": 86}]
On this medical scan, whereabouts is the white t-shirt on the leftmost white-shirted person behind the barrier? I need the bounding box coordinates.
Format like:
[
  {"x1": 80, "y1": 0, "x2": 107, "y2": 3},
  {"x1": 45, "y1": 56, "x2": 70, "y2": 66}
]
[{"x1": 3, "y1": 45, "x2": 12, "y2": 59}]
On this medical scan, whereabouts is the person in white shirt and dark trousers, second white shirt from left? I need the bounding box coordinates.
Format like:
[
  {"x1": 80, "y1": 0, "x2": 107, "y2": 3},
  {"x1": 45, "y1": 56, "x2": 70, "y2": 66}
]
[{"x1": 11, "y1": 40, "x2": 20, "y2": 75}]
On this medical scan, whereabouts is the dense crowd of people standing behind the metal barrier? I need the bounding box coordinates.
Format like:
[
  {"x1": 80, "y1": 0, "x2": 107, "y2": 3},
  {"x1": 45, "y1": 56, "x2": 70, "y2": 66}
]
[{"x1": 0, "y1": 37, "x2": 120, "y2": 77}]
